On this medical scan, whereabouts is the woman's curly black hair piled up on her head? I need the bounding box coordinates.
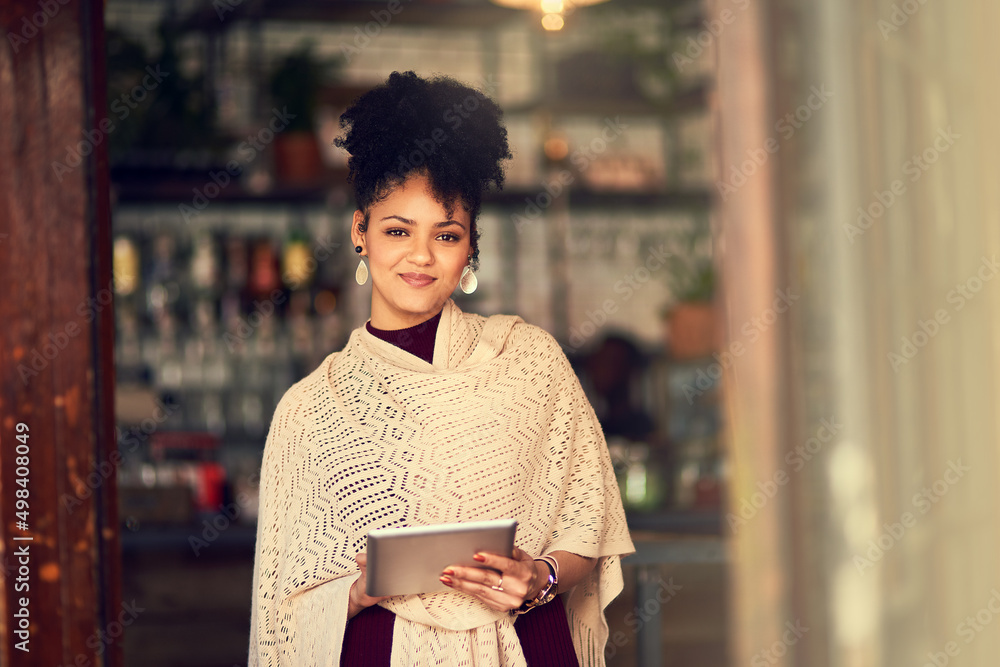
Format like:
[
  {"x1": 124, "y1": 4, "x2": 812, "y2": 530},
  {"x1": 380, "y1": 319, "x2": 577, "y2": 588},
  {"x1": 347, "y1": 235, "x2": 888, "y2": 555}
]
[{"x1": 334, "y1": 71, "x2": 512, "y2": 269}]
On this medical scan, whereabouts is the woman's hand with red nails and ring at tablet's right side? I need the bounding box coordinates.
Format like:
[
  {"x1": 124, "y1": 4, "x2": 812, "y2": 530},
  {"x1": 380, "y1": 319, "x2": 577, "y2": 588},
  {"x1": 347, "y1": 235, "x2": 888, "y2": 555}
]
[{"x1": 441, "y1": 547, "x2": 548, "y2": 611}]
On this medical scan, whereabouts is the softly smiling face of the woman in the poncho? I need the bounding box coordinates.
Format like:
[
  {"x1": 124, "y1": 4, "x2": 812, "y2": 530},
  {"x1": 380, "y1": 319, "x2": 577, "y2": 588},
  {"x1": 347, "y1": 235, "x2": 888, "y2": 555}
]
[{"x1": 351, "y1": 174, "x2": 471, "y2": 329}]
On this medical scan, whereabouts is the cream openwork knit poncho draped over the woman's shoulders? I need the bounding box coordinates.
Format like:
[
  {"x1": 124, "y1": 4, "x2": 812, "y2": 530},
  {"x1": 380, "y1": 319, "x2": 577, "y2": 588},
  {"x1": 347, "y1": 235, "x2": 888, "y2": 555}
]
[{"x1": 250, "y1": 300, "x2": 634, "y2": 667}]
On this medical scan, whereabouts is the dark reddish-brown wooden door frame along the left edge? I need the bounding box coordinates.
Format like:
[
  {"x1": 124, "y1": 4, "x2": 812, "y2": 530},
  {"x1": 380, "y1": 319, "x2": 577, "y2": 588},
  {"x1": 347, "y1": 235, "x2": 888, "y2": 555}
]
[{"x1": 0, "y1": 0, "x2": 122, "y2": 667}]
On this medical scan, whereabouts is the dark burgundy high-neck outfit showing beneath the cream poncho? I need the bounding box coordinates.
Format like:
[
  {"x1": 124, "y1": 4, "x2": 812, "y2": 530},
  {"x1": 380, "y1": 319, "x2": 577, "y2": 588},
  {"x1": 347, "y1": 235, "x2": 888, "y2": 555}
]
[{"x1": 340, "y1": 312, "x2": 580, "y2": 667}]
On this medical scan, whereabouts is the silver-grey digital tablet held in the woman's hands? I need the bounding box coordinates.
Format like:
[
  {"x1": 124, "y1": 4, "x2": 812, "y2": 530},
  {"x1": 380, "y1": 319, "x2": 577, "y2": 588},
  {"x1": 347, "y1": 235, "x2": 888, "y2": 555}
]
[{"x1": 365, "y1": 519, "x2": 517, "y2": 596}]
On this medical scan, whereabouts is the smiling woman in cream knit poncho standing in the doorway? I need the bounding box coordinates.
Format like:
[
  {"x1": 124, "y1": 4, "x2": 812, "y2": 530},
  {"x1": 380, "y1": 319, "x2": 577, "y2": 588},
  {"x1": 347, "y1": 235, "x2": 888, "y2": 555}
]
[{"x1": 250, "y1": 72, "x2": 633, "y2": 667}]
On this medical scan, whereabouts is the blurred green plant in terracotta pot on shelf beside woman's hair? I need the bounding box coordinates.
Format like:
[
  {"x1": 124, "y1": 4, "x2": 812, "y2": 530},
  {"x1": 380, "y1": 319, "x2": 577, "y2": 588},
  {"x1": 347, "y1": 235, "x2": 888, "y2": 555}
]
[{"x1": 270, "y1": 42, "x2": 341, "y2": 187}]
